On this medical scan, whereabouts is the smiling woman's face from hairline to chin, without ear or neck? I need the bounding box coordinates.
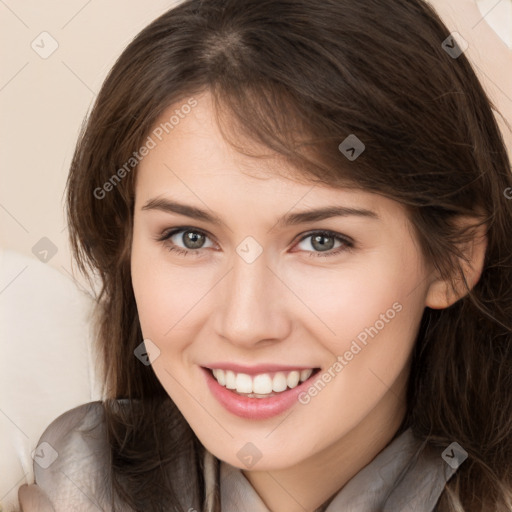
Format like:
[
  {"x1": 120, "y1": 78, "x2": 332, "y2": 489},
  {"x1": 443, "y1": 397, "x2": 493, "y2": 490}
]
[{"x1": 131, "y1": 94, "x2": 431, "y2": 469}]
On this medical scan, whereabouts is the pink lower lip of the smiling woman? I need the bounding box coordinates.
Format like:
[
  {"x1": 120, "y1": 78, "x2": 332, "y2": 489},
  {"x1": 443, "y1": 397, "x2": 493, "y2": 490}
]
[{"x1": 201, "y1": 367, "x2": 318, "y2": 420}]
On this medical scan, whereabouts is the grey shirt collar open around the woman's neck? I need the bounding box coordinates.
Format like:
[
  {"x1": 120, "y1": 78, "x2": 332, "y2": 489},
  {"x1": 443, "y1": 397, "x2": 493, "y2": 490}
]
[{"x1": 215, "y1": 428, "x2": 456, "y2": 512}]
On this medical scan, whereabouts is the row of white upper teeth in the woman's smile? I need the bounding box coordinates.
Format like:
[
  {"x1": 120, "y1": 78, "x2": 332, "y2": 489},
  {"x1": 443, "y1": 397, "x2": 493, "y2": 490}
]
[{"x1": 212, "y1": 368, "x2": 313, "y2": 398}]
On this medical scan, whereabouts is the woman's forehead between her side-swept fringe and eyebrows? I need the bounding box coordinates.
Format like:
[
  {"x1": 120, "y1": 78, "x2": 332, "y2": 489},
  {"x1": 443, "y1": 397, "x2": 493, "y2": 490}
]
[{"x1": 136, "y1": 93, "x2": 405, "y2": 222}]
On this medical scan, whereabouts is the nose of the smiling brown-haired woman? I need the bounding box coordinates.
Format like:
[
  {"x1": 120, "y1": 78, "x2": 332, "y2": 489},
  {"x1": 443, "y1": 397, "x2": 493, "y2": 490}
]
[{"x1": 214, "y1": 247, "x2": 293, "y2": 348}]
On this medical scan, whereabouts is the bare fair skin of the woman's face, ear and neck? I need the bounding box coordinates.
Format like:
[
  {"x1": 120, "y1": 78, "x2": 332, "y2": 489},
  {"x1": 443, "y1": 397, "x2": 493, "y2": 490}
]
[{"x1": 131, "y1": 93, "x2": 485, "y2": 512}]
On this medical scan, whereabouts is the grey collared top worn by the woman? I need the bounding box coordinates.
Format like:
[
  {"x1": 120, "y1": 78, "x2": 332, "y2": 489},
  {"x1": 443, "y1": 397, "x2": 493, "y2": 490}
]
[{"x1": 34, "y1": 401, "x2": 457, "y2": 512}]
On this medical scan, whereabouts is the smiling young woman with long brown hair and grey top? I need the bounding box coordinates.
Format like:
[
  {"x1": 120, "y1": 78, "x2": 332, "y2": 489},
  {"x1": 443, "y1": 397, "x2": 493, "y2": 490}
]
[{"x1": 20, "y1": 0, "x2": 512, "y2": 512}]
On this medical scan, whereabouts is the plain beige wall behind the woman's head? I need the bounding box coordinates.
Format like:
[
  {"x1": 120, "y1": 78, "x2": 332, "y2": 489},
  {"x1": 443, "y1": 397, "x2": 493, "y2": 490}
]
[{"x1": 0, "y1": 0, "x2": 512, "y2": 292}]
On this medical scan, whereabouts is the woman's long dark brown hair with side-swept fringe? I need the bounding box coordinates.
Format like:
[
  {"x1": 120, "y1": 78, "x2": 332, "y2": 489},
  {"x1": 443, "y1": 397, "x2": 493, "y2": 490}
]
[{"x1": 67, "y1": 0, "x2": 512, "y2": 512}]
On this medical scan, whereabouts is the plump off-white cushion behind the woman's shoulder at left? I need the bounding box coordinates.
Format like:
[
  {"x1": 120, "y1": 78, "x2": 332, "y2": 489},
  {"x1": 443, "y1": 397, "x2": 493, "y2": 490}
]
[{"x1": 0, "y1": 249, "x2": 100, "y2": 512}]
